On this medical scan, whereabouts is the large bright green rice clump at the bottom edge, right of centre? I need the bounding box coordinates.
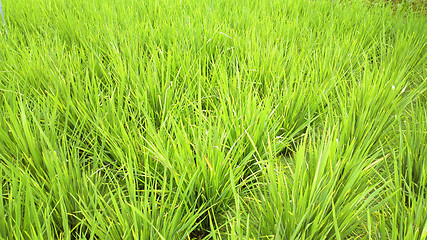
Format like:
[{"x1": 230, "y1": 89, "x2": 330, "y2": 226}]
[{"x1": 241, "y1": 122, "x2": 392, "y2": 239}]
